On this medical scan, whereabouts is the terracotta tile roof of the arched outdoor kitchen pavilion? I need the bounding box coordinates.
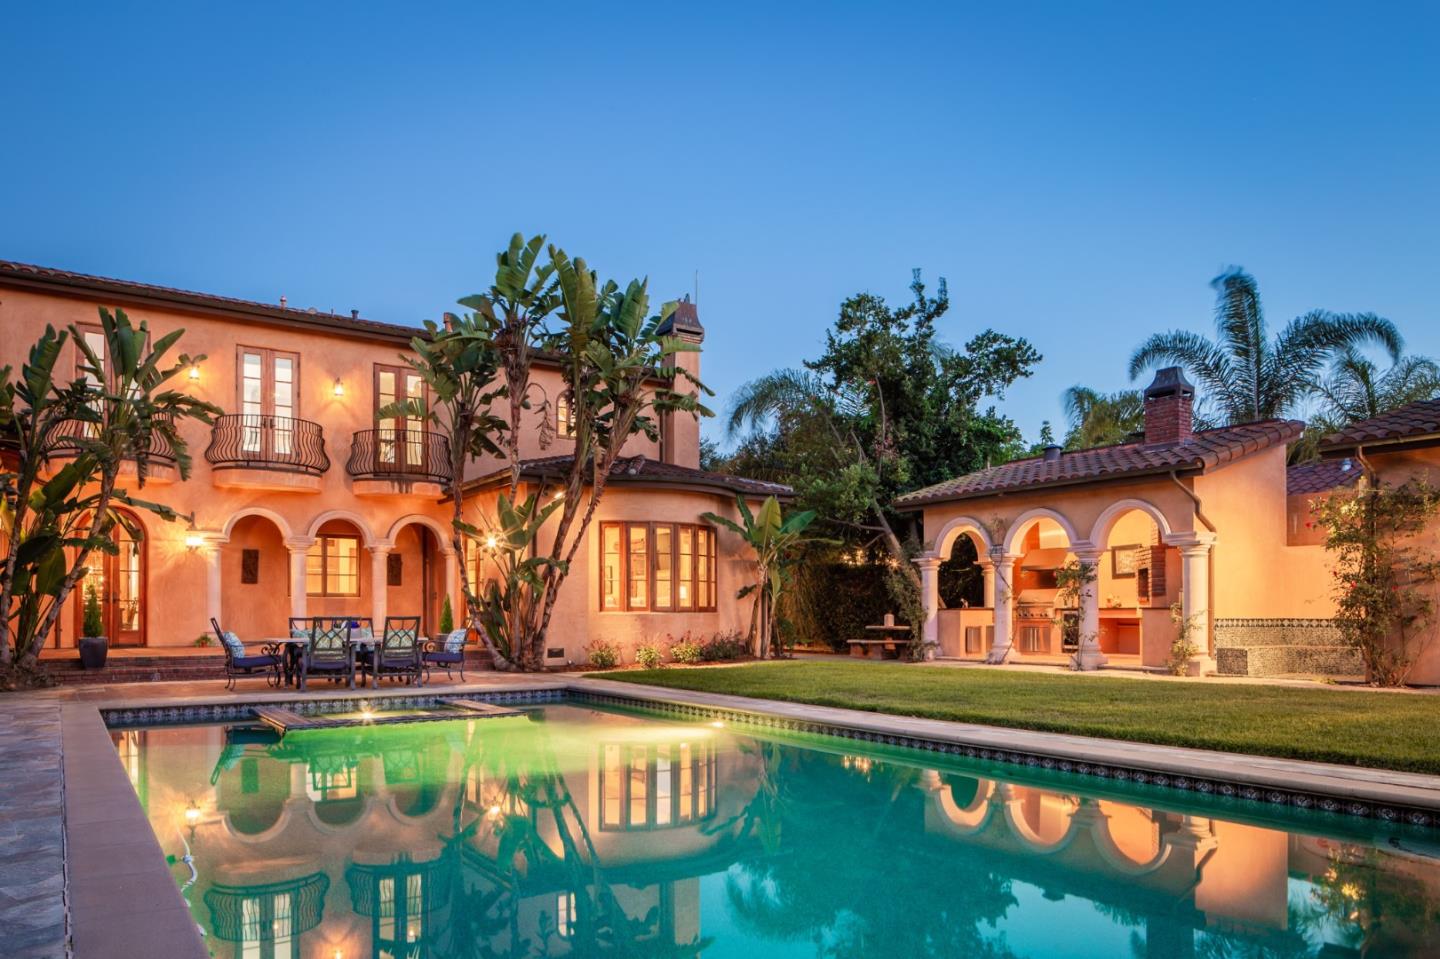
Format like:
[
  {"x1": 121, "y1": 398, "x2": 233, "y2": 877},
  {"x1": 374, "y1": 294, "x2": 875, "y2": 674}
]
[{"x1": 896, "y1": 419, "x2": 1305, "y2": 508}]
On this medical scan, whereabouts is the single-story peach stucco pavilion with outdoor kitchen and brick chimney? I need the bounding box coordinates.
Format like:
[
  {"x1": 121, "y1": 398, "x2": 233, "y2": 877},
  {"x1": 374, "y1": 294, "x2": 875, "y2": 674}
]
[{"x1": 899, "y1": 367, "x2": 1440, "y2": 684}]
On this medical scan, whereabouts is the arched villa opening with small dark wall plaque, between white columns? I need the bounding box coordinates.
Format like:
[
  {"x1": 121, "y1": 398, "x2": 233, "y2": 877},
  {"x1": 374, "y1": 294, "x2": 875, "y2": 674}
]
[{"x1": 220, "y1": 514, "x2": 289, "y2": 642}]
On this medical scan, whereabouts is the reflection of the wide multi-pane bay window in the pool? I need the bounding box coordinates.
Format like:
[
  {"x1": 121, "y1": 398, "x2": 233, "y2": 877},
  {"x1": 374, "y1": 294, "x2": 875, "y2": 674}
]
[{"x1": 600, "y1": 740, "x2": 716, "y2": 829}]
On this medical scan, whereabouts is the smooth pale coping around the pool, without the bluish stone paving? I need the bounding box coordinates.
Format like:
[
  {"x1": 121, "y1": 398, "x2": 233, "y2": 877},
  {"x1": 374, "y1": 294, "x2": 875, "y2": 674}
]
[{"x1": 39, "y1": 677, "x2": 1440, "y2": 959}]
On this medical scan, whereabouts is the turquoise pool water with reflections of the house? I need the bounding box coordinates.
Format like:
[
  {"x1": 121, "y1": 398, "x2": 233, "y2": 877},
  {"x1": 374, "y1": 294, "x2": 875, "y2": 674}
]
[{"x1": 112, "y1": 706, "x2": 1440, "y2": 959}]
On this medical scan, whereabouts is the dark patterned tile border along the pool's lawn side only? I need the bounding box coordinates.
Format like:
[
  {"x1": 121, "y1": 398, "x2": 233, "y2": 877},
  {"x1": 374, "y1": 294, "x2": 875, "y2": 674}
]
[{"x1": 567, "y1": 690, "x2": 1440, "y2": 829}]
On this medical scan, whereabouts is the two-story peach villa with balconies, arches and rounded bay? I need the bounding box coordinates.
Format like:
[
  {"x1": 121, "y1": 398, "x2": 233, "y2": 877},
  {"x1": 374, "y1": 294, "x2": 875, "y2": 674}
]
[{"x1": 0, "y1": 261, "x2": 789, "y2": 665}]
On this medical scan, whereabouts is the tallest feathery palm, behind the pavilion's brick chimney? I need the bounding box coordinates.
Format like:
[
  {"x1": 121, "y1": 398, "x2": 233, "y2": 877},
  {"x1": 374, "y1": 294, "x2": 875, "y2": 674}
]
[{"x1": 1130, "y1": 268, "x2": 1403, "y2": 423}]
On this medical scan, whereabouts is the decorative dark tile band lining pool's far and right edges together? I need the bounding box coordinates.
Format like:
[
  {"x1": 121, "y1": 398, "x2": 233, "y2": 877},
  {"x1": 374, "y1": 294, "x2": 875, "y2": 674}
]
[{"x1": 101, "y1": 688, "x2": 1440, "y2": 829}]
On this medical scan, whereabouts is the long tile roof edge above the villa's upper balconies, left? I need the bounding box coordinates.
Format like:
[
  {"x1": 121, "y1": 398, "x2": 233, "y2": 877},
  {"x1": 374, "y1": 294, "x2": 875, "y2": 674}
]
[{"x1": 0, "y1": 259, "x2": 422, "y2": 343}]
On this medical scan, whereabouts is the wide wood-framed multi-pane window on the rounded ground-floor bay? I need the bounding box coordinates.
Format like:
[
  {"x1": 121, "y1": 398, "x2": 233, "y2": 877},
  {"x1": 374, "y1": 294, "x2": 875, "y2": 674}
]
[{"x1": 600, "y1": 523, "x2": 716, "y2": 612}]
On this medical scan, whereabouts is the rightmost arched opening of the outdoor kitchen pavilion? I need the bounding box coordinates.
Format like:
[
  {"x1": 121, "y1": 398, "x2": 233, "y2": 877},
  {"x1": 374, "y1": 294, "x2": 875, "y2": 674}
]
[{"x1": 1093, "y1": 504, "x2": 1181, "y2": 665}]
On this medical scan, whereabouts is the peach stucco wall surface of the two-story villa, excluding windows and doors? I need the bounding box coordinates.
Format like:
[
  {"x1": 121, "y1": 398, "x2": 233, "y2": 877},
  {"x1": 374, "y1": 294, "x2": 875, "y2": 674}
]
[{"x1": 0, "y1": 285, "x2": 720, "y2": 659}]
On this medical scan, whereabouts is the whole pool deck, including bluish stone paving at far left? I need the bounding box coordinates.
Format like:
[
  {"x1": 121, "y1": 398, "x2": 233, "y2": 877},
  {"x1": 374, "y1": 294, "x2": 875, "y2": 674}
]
[{"x1": 8, "y1": 672, "x2": 1440, "y2": 959}]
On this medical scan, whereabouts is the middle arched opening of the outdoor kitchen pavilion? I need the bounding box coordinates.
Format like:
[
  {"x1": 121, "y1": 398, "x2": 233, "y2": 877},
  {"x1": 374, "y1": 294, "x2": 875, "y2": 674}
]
[{"x1": 996, "y1": 511, "x2": 1080, "y2": 659}]
